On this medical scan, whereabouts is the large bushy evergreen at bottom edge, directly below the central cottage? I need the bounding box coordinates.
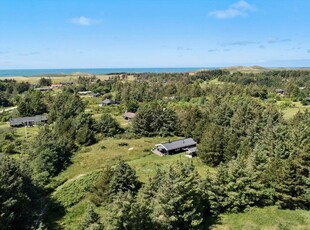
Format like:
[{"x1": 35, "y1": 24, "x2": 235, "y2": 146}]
[{"x1": 144, "y1": 163, "x2": 206, "y2": 229}]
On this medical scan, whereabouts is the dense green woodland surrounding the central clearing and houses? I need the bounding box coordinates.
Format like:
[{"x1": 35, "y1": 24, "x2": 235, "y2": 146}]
[{"x1": 0, "y1": 70, "x2": 310, "y2": 230}]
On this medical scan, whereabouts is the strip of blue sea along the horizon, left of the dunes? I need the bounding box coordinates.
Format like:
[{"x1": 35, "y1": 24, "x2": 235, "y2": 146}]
[{"x1": 0, "y1": 67, "x2": 218, "y2": 78}]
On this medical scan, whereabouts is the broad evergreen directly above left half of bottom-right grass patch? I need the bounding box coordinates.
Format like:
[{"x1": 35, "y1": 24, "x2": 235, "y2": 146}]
[{"x1": 206, "y1": 157, "x2": 272, "y2": 214}]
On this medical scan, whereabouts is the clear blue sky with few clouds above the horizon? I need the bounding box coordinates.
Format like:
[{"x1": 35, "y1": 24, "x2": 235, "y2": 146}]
[{"x1": 0, "y1": 0, "x2": 310, "y2": 69}]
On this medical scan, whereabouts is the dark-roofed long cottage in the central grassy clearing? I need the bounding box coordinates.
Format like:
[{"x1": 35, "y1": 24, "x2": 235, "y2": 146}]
[{"x1": 152, "y1": 138, "x2": 197, "y2": 156}]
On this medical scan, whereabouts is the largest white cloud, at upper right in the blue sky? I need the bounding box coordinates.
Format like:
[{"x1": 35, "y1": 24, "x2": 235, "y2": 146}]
[{"x1": 209, "y1": 0, "x2": 255, "y2": 19}]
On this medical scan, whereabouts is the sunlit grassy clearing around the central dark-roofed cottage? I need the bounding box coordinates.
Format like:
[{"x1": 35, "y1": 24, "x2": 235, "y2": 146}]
[{"x1": 56, "y1": 137, "x2": 211, "y2": 182}]
